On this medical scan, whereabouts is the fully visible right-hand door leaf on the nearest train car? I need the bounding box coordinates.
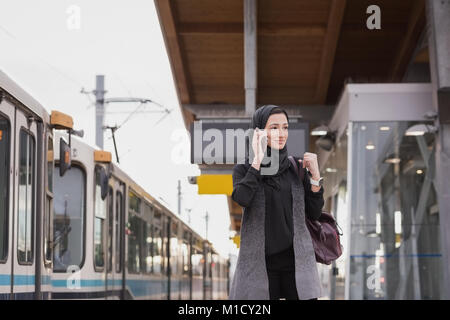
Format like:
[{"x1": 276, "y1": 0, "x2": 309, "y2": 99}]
[{"x1": 12, "y1": 109, "x2": 37, "y2": 299}]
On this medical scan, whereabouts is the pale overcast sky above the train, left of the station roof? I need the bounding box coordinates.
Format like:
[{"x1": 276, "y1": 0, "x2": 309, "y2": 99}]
[{"x1": 0, "y1": 0, "x2": 236, "y2": 254}]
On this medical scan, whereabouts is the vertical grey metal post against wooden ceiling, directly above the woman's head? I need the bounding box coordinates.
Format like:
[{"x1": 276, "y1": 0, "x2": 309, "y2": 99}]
[{"x1": 244, "y1": 0, "x2": 258, "y2": 116}]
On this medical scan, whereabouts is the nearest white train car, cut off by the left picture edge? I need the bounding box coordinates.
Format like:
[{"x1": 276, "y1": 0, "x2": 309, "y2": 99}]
[{"x1": 0, "y1": 71, "x2": 73, "y2": 299}]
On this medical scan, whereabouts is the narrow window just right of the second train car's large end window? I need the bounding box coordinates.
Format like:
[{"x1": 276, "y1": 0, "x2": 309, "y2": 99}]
[{"x1": 94, "y1": 167, "x2": 107, "y2": 269}]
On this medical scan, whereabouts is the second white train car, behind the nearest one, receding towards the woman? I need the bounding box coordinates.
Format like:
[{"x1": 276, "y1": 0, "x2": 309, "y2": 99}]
[{"x1": 52, "y1": 134, "x2": 228, "y2": 299}]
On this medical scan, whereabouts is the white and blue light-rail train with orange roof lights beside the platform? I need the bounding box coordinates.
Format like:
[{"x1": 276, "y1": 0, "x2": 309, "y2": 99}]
[{"x1": 0, "y1": 71, "x2": 230, "y2": 300}]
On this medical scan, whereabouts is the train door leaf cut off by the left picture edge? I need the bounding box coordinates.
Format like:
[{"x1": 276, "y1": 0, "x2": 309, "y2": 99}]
[{"x1": 0, "y1": 101, "x2": 15, "y2": 299}]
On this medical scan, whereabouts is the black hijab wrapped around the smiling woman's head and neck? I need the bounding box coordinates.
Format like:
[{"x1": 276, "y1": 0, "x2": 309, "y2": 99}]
[{"x1": 251, "y1": 104, "x2": 290, "y2": 190}]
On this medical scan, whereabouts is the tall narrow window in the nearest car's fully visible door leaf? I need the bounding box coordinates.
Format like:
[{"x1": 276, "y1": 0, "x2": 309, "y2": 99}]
[{"x1": 17, "y1": 129, "x2": 35, "y2": 264}]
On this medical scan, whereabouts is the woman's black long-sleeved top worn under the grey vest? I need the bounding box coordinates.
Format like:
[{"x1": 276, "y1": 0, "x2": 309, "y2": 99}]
[{"x1": 231, "y1": 158, "x2": 324, "y2": 255}]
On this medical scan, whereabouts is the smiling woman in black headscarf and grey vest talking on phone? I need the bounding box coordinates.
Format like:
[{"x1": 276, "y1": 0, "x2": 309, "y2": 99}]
[{"x1": 229, "y1": 105, "x2": 324, "y2": 300}]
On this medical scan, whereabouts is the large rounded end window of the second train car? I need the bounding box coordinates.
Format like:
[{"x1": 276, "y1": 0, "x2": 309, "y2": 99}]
[{"x1": 53, "y1": 164, "x2": 86, "y2": 272}]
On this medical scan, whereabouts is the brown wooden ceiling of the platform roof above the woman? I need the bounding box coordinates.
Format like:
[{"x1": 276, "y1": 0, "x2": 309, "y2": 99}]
[{"x1": 155, "y1": 0, "x2": 427, "y2": 232}]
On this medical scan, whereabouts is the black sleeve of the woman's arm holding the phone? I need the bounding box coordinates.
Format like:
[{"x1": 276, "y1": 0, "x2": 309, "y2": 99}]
[{"x1": 231, "y1": 165, "x2": 261, "y2": 207}]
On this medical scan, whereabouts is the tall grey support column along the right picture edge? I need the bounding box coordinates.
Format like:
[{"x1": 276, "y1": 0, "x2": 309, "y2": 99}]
[{"x1": 427, "y1": 0, "x2": 450, "y2": 299}]
